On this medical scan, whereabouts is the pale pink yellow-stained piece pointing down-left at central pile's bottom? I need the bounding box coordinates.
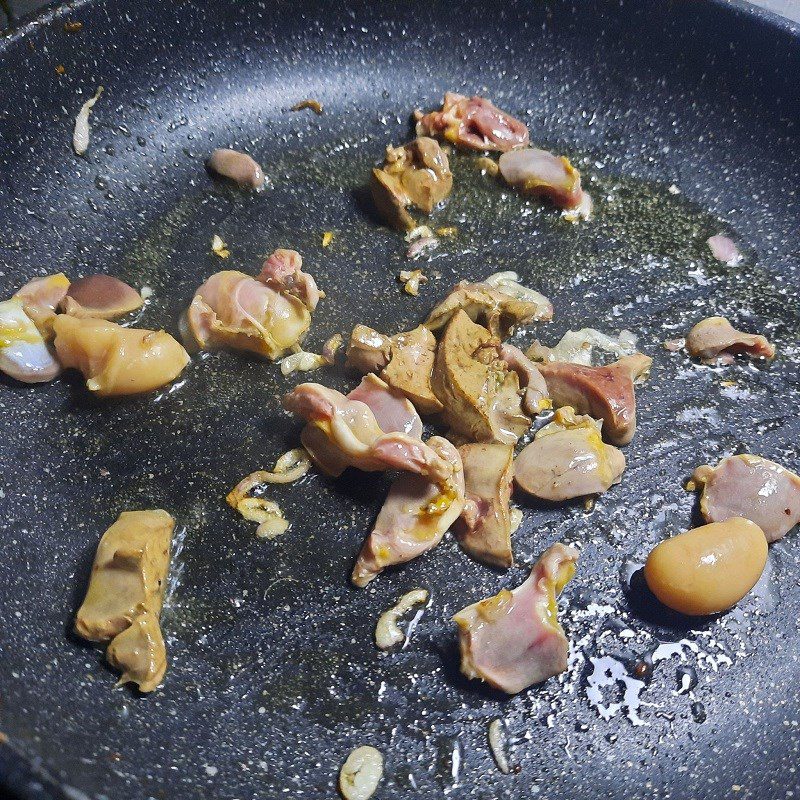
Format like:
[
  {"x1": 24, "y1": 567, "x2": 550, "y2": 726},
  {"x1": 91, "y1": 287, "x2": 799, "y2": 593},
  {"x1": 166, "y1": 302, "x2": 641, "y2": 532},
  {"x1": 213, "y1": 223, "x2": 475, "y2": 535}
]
[{"x1": 351, "y1": 436, "x2": 464, "y2": 587}]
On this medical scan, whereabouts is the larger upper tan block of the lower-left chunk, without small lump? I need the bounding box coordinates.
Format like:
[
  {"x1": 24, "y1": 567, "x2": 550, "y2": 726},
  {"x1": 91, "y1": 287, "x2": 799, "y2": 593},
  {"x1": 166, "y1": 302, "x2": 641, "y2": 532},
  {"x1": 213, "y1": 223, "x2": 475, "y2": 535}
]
[{"x1": 75, "y1": 509, "x2": 175, "y2": 642}]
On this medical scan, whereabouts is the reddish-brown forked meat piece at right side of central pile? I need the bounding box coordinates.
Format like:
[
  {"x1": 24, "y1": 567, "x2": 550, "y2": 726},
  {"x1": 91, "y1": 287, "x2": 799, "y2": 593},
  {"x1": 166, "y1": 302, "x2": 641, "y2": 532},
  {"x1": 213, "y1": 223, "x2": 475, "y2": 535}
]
[{"x1": 539, "y1": 353, "x2": 653, "y2": 445}]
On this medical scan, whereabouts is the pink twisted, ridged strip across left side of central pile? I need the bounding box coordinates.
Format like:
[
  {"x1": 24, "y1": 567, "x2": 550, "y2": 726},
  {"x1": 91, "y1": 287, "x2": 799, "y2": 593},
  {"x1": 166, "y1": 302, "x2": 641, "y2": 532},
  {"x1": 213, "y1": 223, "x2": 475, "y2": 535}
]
[{"x1": 282, "y1": 383, "x2": 460, "y2": 484}]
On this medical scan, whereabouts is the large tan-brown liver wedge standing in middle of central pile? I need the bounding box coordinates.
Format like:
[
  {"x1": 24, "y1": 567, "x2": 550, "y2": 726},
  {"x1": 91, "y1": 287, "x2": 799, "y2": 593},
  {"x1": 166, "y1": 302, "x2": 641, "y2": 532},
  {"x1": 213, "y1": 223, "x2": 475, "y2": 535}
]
[{"x1": 431, "y1": 311, "x2": 531, "y2": 444}]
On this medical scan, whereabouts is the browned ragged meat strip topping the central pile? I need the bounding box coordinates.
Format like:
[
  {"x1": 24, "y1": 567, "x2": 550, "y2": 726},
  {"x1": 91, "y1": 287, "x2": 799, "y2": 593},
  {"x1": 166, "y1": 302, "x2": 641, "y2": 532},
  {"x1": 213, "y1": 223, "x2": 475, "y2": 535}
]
[{"x1": 424, "y1": 281, "x2": 553, "y2": 338}]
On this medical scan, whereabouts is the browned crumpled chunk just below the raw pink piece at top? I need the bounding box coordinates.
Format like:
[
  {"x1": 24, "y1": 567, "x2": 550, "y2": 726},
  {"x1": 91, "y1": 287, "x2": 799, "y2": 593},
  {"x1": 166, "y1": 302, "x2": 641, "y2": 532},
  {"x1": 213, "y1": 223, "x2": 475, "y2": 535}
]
[{"x1": 370, "y1": 136, "x2": 453, "y2": 230}]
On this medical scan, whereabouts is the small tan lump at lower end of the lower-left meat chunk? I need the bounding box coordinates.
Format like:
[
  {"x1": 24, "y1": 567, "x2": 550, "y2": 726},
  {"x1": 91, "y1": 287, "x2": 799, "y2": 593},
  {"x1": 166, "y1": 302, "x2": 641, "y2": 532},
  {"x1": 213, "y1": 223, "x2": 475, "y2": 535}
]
[{"x1": 106, "y1": 611, "x2": 167, "y2": 692}]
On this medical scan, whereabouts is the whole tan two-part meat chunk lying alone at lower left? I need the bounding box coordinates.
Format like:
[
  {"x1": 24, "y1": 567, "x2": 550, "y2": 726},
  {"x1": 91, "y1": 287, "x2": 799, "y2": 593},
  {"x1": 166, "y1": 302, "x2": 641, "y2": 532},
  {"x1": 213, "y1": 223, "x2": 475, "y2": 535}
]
[{"x1": 75, "y1": 509, "x2": 175, "y2": 692}]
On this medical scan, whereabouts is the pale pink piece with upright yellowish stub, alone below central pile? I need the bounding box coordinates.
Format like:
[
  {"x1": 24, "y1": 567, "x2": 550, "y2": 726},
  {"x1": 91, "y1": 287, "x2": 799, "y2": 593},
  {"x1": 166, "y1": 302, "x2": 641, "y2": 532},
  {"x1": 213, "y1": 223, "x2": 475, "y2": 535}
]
[{"x1": 453, "y1": 543, "x2": 578, "y2": 694}]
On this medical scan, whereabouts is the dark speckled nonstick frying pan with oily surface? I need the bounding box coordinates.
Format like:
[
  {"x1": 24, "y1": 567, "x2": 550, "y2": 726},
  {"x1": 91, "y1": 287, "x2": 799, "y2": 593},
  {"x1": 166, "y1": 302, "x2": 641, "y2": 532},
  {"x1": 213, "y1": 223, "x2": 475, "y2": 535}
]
[{"x1": 0, "y1": 0, "x2": 800, "y2": 800}]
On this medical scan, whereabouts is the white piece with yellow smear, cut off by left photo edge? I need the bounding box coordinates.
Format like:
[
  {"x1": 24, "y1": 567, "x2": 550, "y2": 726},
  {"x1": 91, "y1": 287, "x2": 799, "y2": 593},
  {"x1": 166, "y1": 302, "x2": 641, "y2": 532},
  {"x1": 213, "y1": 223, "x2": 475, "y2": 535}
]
[{"x1": 0, "y1": 299, "x2": 61, "y2": 383}]
